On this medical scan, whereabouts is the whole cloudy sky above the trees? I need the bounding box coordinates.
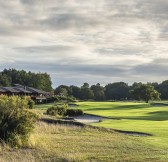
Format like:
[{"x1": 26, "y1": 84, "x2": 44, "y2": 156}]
[{"x1": 0, "y1": 0, "x2": 168, "y2": 87}]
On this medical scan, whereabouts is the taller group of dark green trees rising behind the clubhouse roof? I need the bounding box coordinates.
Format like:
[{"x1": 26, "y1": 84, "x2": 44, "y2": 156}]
[{"x1": 0, "y1": 69, "x2": 53, "y2": 92}]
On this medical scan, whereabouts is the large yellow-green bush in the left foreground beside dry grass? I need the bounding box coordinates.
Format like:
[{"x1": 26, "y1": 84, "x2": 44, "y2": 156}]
[{"x1": 0, "y1": 96, "x2": 38, "y2": 147}]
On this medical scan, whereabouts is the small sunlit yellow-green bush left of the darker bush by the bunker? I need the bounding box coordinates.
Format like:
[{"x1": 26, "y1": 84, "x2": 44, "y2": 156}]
[{"x1": 47, "y1": 104, "x2": 67, "y2": 116}]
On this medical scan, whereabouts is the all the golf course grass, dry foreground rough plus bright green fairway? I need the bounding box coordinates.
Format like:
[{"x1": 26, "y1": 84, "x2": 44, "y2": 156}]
[{"x1": 25, "y1": 102, "x2": 168, "y2": 162}]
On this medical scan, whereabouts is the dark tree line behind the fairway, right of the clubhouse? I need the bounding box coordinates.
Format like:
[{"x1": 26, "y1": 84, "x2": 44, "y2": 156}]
[{"x1": 54, "y1": 80, "x2": 168, "y2": 102}]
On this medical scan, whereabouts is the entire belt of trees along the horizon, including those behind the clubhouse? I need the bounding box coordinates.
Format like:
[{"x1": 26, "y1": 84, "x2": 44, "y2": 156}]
[{"x1": 0, "y1": 69, "x2": 168, "y2": 102}]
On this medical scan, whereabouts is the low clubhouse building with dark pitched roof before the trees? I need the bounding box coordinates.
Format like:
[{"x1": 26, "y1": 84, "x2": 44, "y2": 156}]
[{"x1": 0, "y1": 84, "x2": 53, "y2": 103}]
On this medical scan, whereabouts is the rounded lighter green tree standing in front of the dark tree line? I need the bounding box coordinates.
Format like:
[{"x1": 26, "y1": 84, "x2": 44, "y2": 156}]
[{"x1": 131, "y1": 84, "x2": 160, "y2": 103}]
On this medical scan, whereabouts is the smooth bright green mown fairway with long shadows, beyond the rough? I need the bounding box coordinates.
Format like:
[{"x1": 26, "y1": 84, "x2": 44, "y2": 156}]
[{"x1": 78, "y1": 102, "x2": 168, "y2": 149}]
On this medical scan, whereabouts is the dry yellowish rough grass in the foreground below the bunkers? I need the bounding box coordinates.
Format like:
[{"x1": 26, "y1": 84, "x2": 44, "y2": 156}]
[{"x1": 0, "y1": 122, "x2": 166, "y2": 162}]
